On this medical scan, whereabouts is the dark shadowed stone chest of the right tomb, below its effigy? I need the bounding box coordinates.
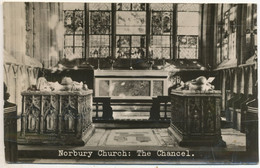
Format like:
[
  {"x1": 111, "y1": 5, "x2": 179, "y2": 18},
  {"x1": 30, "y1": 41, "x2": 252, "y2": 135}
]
[{"x1": 168, "y1": 90, "x2": 225, "y2": 146}]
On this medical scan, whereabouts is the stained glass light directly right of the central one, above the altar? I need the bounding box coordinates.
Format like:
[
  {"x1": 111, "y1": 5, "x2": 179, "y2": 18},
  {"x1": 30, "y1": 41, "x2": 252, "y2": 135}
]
[{"x1": 150, "y1": 4, "x2": 173, "y2": 59}]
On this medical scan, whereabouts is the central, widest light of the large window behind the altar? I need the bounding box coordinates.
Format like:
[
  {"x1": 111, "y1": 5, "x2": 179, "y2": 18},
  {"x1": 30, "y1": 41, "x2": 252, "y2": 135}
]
[{"x1": 116, "y1": 3, "x2": 146, "y2": 58}]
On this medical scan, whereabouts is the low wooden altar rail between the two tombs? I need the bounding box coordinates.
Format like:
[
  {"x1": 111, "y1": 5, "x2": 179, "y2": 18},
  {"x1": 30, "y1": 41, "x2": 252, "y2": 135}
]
[{"x1": 93, "y1": 96, "x2": 171, "y2": 121}]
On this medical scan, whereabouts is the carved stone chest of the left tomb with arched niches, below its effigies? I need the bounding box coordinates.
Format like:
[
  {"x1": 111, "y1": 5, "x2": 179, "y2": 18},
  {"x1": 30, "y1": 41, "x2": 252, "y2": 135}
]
[{"x1": 18, "y1": 90, "x2": 94, "y2": 145}]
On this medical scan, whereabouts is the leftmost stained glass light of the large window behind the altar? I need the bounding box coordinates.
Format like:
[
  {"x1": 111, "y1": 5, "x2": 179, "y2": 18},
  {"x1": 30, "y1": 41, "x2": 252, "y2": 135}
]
[{"x1": 64, "y1": 10, "x2": 85, "y2": 59}]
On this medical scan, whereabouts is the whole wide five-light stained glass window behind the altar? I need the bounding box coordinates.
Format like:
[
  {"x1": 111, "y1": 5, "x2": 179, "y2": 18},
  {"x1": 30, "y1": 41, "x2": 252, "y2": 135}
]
[{"x1": 64, "y1": 3, "x2": 203, "y2": 59}]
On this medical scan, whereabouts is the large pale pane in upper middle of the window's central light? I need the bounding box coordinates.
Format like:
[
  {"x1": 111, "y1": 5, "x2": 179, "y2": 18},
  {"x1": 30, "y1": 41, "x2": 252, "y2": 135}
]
[{"x1": 116, "y1": 12, "x2": 146, "y2": 34}]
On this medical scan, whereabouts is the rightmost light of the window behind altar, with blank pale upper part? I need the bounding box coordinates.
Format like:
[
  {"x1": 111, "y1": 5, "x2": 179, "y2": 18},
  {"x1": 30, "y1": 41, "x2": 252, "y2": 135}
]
[{"x1": 177, "y1": 4, "x2": 200, "y2": 59}]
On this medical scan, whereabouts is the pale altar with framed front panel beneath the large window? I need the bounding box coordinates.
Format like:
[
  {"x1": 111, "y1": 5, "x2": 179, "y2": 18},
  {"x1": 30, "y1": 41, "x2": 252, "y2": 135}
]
[{"x1": 94, "y1": 70, "x2": 168, "y2": 99}]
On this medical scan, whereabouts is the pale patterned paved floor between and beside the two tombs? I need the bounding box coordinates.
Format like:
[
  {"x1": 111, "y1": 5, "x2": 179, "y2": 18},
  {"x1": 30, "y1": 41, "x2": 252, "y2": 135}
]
[{"x1": 18, "y1": 128, "x2": 246, "y2": 151}]
